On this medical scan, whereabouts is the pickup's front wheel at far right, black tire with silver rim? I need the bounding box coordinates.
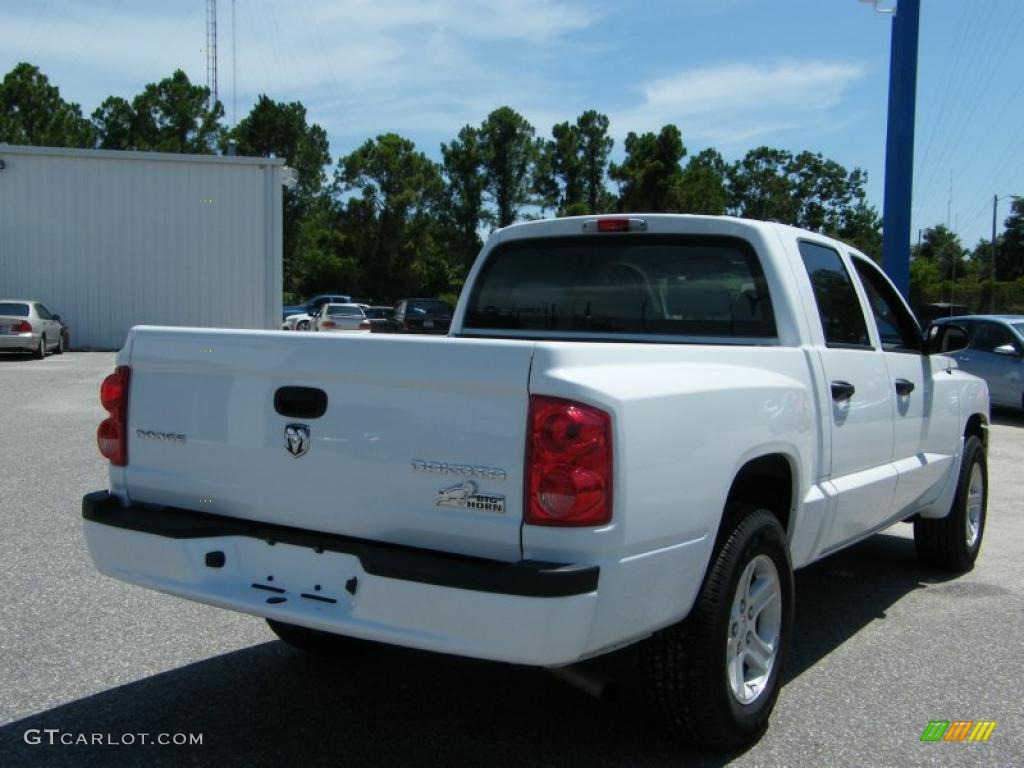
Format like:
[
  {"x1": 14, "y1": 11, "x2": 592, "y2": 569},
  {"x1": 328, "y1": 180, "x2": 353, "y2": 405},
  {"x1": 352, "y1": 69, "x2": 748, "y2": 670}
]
[{"x1": 913, "y1": 435, "x2": 988, "y2": 573}]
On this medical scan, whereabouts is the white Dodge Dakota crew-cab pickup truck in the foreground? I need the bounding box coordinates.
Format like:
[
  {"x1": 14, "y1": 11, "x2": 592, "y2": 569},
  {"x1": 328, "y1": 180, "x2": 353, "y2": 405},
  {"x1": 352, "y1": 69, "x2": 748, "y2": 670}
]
[{"x1": 83, "y1": 215, "x2": 988, "y2": 749}]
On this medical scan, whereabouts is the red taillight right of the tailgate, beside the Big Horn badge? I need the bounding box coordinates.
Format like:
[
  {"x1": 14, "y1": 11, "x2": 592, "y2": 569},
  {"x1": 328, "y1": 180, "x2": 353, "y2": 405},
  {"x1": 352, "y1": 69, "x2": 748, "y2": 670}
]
[{"x1": 524, "y1": 395, "x2": 611, "y2": 525}]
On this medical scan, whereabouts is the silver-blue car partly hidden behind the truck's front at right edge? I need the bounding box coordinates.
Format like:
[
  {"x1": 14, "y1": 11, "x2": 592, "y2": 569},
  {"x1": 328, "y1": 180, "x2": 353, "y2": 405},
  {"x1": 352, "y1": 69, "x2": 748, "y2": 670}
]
[{"x1": 933, "y1": 314, "x2": 1024, "y2": 409}]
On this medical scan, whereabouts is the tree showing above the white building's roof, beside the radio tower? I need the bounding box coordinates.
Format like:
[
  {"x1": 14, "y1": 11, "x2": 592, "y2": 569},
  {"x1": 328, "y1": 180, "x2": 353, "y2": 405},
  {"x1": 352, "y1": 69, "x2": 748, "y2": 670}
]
[{"x1": 124, "y1": 70, "x2": 224, "y2": 155}]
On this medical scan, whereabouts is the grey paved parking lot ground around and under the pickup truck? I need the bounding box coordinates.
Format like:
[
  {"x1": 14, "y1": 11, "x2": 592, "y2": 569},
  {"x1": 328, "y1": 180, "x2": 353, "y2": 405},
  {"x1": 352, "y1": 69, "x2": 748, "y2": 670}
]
[{"x1": 0, "y1": 353, "x2": 1024, "y2": 768}]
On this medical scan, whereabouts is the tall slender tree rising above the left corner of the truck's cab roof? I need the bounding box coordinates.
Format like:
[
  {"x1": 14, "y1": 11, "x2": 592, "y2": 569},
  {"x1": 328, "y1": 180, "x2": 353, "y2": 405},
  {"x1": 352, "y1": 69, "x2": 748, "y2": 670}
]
[{"x1": 479, "y1": 106, "x2": 539, "y2": 227}]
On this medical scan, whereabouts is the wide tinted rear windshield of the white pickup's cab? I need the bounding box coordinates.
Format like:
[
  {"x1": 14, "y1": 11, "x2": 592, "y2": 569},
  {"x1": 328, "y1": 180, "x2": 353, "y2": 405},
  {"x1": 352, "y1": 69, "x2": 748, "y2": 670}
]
[{"x1": 463, "y1": 234, "x2": 776, "y2": 339}]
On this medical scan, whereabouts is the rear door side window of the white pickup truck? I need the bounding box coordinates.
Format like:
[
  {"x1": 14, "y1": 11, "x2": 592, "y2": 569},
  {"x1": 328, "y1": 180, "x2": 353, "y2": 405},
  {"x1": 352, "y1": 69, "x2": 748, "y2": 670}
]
[{"x1": 799, "y1": 241, "x2": 871, "y2": 349}]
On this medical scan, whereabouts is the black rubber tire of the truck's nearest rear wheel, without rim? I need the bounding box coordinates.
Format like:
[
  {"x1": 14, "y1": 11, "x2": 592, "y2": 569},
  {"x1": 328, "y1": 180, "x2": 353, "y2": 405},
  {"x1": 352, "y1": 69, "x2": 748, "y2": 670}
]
[{"x1": 641, "y1": 507, "x2": 794, "y2": 752}]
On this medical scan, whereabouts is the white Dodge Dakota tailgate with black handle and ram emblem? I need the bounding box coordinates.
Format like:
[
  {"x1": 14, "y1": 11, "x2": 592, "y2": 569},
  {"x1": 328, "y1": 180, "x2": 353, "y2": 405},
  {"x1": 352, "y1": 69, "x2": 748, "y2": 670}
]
[{"x1": 125, "y1": 328, "x2": 534, "y2": 560}]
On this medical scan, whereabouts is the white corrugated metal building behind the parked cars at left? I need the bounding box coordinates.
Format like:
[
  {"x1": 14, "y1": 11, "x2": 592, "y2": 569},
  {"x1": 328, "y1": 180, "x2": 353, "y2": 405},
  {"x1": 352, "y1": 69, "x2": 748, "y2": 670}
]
[{"x1": 0, "y1": 144, "x2": 289, "y2": 349}]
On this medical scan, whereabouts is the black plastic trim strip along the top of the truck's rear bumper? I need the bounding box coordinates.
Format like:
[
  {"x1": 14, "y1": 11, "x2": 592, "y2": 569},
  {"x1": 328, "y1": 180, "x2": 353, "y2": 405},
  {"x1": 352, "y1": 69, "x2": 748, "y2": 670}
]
[{"x1": 88, "y1": 490, "x2": 600, "y2": 597}]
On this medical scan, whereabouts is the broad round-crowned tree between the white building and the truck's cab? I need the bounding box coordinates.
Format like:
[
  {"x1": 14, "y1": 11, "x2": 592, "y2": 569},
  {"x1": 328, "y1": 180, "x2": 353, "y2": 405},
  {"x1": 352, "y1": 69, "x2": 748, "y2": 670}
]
[{"x1": 335, "y1": 133, "x2": 447, "y2": 300}]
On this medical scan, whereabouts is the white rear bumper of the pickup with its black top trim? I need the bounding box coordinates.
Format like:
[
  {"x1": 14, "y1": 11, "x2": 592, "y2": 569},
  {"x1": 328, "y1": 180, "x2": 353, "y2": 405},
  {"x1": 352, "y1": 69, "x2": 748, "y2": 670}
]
[{"x1": 82, "y1": 492, "x2": 599, "y2": 665}]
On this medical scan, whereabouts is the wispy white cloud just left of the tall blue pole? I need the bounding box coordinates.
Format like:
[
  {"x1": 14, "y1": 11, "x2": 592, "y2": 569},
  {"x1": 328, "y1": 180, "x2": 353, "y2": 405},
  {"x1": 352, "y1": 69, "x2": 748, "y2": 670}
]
[{"x1": 613, "y1": 60, "x2": 865, "y2": 145}]
